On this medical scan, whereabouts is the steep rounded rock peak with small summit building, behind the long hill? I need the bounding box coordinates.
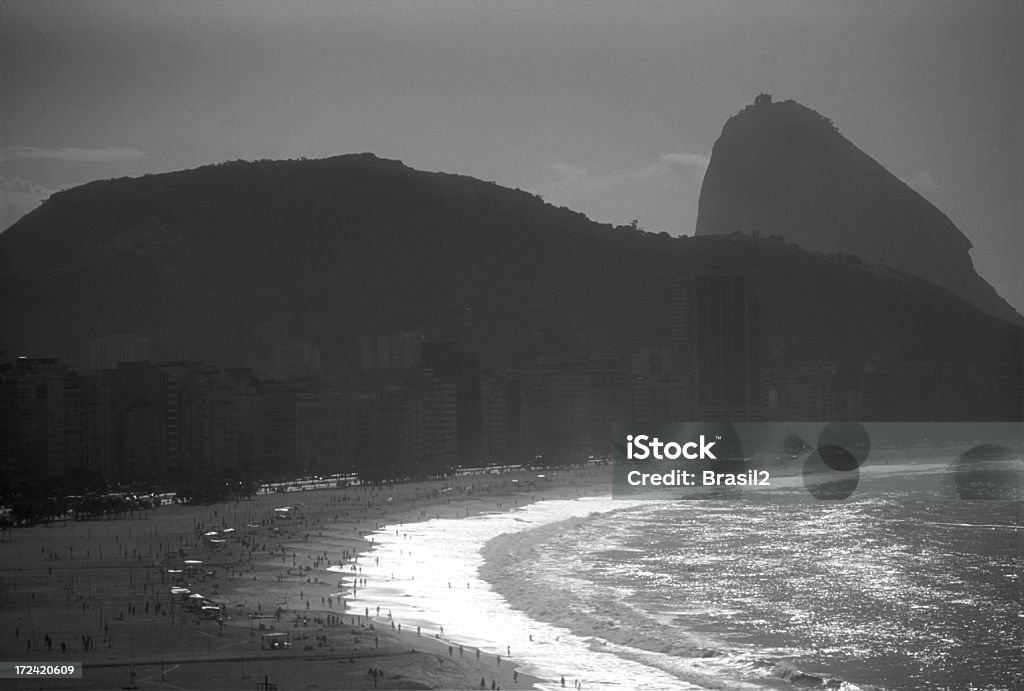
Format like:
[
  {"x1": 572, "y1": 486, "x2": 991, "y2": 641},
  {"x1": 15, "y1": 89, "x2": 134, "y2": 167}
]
[{"x1": 696, "y1": 94, "x2": 1024, "y2": 323}]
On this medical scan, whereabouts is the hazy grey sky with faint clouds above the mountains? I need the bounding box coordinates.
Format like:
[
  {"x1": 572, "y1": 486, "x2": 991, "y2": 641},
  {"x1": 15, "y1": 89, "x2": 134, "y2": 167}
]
[{"x1": 0, "y1": 0, "x2": 1024, "y2": 312}]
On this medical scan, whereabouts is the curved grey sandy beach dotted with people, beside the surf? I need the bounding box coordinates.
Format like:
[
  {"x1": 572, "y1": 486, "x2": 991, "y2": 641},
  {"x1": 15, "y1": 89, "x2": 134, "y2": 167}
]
[{"x1": 0, "y1": 468, "x2": 610, "y2": 691}]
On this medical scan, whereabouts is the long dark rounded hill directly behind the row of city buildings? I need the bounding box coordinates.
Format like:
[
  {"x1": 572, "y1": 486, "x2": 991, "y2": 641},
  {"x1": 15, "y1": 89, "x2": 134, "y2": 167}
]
[{"x1": 0, "y1": 155, "x2": 1022, "y2": 403}]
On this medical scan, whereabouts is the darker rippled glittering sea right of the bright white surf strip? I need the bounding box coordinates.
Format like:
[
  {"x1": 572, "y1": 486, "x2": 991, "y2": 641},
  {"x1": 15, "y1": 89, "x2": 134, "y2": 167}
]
[{"x1": 480, "y1": 500, "x2": 1024, "y2": 690}]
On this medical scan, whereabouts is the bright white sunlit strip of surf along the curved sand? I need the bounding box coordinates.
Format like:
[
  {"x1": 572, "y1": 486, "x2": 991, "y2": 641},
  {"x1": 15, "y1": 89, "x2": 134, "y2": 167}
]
[{"x1": 349, "y1": 498, "x2": 720, "y2": 691}]
